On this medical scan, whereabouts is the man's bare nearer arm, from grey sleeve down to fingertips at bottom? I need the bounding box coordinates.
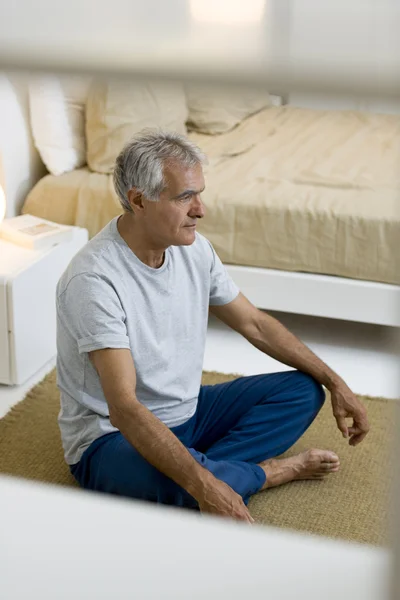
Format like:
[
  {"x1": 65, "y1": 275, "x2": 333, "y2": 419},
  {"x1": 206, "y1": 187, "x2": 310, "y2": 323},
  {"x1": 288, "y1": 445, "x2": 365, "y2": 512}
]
[{"x1": 89, "y1": 348, "x2": 253, "y2": 523}]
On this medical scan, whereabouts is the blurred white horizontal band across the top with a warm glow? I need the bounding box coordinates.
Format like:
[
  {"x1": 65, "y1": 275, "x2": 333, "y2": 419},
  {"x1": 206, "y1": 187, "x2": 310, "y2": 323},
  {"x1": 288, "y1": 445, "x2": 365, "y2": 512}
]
[{"x1": 0, "y1": 0, "x2": 400, "y2": 97}]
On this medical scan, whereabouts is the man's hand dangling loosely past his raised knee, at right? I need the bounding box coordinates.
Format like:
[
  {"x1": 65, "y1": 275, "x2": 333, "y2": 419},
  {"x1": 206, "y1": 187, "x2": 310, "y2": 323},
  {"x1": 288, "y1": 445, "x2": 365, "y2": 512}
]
[{"x1": 330, "y1": 382, "x2": 369, "y2": 446}]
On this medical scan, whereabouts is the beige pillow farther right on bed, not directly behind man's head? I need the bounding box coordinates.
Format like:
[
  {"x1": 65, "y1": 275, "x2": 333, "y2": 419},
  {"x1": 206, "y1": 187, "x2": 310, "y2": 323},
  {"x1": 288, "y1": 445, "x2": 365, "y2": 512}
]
[{"x1": 185, "y1": 84, "x2": 271, "y2": 134}]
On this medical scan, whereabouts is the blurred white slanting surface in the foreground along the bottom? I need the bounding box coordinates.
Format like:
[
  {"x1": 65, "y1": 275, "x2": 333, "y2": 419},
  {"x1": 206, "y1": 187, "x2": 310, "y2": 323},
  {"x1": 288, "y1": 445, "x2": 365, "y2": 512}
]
[{"x1": 0, "y1": 477, "x2": 391, "y2": 600}]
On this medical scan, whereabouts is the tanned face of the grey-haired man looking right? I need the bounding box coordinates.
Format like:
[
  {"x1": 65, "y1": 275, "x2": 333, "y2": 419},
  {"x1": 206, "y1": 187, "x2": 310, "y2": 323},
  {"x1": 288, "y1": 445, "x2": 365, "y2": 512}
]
[{"x1": 143, "y1": 162, "x2": 205, "y2": 248}]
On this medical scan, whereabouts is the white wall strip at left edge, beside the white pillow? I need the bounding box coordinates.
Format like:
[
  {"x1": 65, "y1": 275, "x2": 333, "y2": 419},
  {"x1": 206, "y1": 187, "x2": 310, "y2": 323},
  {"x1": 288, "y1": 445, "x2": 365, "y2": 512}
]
[{"x1": 0, "y1": 73, "x2": 46, "y2": 217}]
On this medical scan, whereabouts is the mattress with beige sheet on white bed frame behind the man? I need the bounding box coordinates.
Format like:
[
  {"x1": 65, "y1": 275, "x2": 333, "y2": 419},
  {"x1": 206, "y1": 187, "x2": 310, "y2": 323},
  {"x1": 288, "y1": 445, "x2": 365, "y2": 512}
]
[{"x1": 23, "y1": 107, "x2": 400, "y2": 284}]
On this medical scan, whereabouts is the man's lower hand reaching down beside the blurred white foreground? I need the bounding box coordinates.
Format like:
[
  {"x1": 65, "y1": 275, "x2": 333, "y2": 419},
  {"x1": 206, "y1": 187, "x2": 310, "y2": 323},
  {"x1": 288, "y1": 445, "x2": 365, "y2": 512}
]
[{"x1": 196, "y1": 477, "x2": 254, "y2": 523}]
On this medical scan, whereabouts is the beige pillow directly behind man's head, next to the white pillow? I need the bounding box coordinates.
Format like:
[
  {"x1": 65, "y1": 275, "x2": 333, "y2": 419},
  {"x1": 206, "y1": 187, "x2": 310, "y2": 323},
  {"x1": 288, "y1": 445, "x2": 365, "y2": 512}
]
[{"x1": 86, "y1": 81, "x2": 187, "y2": 173}]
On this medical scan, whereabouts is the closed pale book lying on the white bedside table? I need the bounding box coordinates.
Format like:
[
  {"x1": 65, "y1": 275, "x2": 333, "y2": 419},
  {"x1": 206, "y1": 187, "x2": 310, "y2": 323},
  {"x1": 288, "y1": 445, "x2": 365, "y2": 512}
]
[{"x1": 0, "y1": 215, "x2": 73, "y2": 250}]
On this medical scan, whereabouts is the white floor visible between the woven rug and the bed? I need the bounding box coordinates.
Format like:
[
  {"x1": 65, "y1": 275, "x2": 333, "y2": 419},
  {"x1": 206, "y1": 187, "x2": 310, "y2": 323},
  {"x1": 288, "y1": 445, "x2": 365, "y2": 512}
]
[{"x1": 0, "y1": 313, "x2": 400, "y2": 418}]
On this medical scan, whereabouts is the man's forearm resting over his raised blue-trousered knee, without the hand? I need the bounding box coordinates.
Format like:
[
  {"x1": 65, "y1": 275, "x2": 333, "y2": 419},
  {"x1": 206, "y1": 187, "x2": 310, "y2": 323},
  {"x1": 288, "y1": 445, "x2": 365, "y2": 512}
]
[{"x1": 248, "y1": 311, "x2": 343, "y2": 389}]
